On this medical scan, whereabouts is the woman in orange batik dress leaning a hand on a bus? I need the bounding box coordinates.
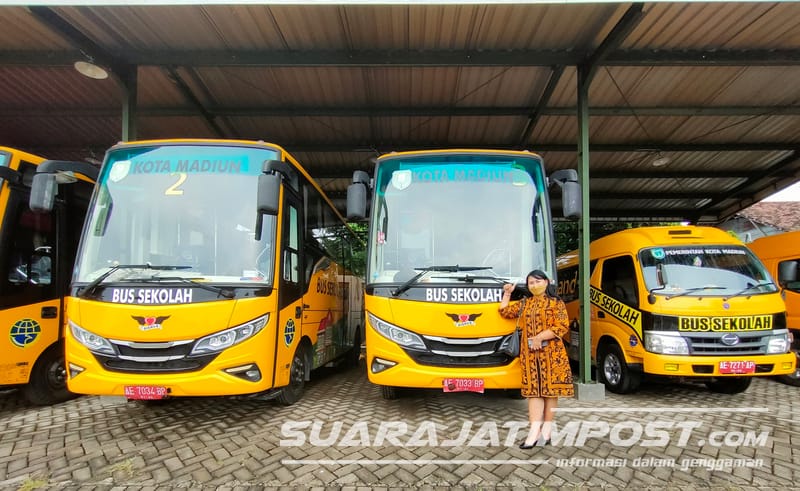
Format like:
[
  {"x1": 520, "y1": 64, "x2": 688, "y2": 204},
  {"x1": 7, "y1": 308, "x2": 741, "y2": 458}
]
[{"x1": 500, "y1": 269, "x2": 575, "y2": 448}]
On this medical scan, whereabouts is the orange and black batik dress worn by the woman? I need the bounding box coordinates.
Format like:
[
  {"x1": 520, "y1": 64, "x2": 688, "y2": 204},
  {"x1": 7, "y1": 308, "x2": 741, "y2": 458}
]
[{"x1": 500, "y1": 295, "x2": 575, "y2": 397}]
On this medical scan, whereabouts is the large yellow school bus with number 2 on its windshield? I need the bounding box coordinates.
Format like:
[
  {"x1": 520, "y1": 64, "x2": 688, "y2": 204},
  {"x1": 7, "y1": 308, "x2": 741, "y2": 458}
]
[{"x1": 29, "y1": 139, "x2": 363, "y2": 405}]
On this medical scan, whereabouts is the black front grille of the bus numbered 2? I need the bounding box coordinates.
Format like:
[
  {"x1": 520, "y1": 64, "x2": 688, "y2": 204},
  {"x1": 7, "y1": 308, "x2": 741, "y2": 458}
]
[{"x1": 94, "y1": 340, "x2": 218, "y2": 374}]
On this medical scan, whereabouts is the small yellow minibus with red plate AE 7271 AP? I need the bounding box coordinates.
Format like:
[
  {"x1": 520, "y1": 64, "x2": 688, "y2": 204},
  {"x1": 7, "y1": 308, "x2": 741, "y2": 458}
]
[{"x1": 558, "y1": 226, "x2": 795, "y2": 394}]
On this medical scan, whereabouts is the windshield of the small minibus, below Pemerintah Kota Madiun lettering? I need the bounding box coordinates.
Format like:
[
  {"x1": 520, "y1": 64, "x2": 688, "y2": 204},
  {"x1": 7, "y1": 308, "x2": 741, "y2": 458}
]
[{"x1": 639, "y1": 245, "x2": 777, "y2": 297}]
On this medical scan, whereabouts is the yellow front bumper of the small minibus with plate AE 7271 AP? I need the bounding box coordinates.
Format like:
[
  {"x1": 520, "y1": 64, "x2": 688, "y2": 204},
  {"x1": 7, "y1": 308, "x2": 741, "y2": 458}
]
[{"x1": 642, "y1": 353, "x2": 796, "y2": 377}]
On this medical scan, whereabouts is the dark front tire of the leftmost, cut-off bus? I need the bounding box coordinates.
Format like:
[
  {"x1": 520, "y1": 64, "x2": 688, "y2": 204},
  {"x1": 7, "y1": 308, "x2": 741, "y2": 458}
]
[{"x1": 22, "y1": 343, "x2": 76, "y2": 406}]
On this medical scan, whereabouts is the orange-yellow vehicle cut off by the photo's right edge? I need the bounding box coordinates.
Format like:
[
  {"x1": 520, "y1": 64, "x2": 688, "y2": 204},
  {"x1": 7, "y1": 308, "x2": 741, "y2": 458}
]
[{"x1": 747, "y1": 231, "x2": 800, "y2": 386}]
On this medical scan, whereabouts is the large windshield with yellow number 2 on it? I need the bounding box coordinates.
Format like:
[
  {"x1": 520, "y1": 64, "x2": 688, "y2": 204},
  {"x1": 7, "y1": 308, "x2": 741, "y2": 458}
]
[{"x1": 74, "y1": 144, "x2": 280, "y2": 284}]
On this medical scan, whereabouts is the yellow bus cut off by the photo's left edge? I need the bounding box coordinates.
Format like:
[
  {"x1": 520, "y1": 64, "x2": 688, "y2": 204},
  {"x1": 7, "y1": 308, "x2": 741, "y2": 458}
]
[{"x1": 0, "y1": 147, "x2": 96, "y2": 404}]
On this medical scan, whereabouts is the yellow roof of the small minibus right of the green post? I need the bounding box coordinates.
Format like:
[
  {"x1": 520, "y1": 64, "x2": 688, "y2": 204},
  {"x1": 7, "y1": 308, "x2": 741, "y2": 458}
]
[{"x1": 556, "y1": 225, "x2": 744, "y2": 268}]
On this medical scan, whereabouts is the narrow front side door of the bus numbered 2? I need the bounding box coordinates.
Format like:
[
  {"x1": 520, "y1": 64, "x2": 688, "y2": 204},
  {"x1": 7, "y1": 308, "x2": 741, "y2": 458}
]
[{"x1": 273, "y1": 184, "x2": 306, "y2": 387}]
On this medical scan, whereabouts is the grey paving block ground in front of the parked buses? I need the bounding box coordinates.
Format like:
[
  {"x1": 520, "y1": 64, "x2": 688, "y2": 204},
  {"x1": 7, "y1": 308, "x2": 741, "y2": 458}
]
[{"x1": 0, "y1": 365, "x2": 800, "y2": 491}]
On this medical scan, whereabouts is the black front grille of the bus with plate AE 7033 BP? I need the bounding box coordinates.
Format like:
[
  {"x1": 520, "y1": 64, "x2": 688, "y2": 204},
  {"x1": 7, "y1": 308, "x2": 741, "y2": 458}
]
[{"x1": 406, "y1": 336, "x2": 513, "y2": 367}]
